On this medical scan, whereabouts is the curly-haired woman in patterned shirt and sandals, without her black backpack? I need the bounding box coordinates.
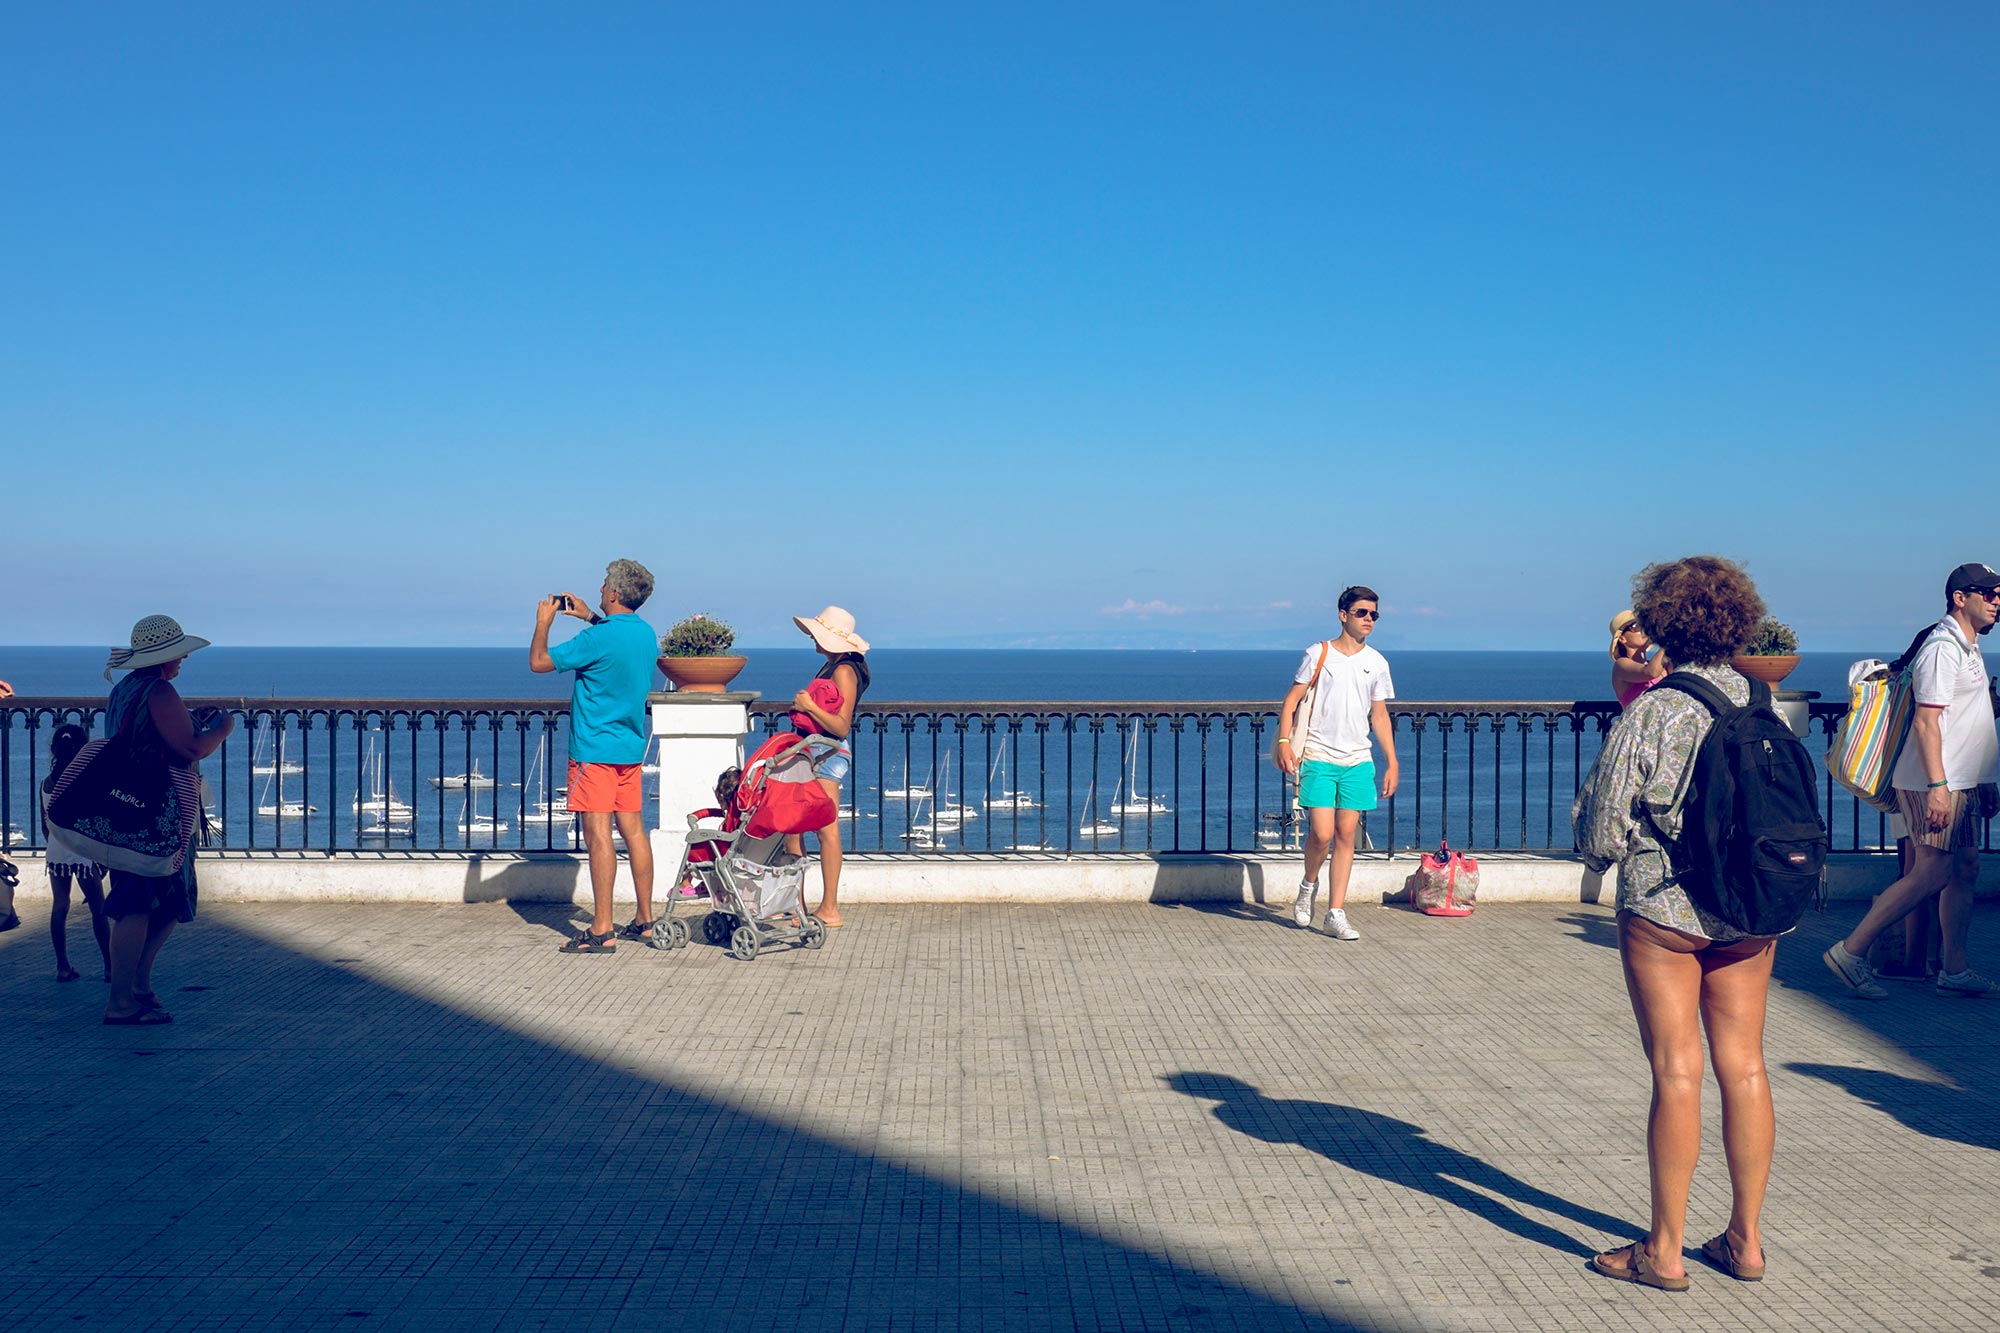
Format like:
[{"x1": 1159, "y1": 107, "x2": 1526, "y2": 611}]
[{"x1": 1572, "y1": 556, "x2": 1776, "y2": 1291}]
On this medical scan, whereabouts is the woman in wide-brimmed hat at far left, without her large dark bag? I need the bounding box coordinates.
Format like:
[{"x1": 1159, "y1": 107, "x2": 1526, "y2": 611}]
[{"x1": 104, "y1": 616, "x2": 236, "y2": 1027}]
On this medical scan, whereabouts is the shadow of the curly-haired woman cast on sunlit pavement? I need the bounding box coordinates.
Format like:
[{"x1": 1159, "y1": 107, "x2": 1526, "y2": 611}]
[{"x1": 1162, "y1": 1071, "x2": 1632, "y2": 1255}]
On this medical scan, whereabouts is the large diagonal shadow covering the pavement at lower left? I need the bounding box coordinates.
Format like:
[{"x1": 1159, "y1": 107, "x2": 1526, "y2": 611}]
[{"x1": 0, "y1": 915, "x2": 1384, "y2": 1333}]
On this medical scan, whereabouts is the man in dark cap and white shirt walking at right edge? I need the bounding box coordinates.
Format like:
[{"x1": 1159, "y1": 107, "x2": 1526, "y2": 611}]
[{"x1": 1824, "y1": 564, "x2": 2000, "y2": 999}]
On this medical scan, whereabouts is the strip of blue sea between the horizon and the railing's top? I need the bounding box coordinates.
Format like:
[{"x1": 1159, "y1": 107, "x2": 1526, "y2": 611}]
[{"x1": 0, "y1": 644, "x2": 1856, "y2": 703}]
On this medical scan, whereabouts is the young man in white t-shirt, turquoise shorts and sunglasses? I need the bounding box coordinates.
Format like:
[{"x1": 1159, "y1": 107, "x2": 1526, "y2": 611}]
[{"x1": 1278, "y1": 586, "x2": 1396, "y2": 939}]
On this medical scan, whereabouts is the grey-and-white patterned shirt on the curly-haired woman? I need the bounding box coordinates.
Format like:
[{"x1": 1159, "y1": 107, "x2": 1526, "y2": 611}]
[{"x1": 1570, "y1": 662, "x2": 1750, "y2": 943}]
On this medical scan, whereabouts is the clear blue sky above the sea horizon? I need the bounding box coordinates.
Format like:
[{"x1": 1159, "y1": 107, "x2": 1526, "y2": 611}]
[{"x1": 0, "y1": 4, "x2": 2000, "y2": 648}]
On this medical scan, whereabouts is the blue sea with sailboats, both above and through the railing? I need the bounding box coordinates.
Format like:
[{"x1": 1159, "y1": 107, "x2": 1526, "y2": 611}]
[{"x1": 0, "y1": 644, "x2": 1872, "y2": 855}]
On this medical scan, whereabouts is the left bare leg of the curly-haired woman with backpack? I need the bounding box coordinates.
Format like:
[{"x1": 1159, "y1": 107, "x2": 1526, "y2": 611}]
[{"x1": 1618, "y1": 913, "x2": 1706, "y2": 1277}]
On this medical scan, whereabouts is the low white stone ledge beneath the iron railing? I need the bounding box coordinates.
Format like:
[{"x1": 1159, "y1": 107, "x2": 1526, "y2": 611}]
[{"x1": 0, "y1": 851, "x2": 1968, "y2": 903}]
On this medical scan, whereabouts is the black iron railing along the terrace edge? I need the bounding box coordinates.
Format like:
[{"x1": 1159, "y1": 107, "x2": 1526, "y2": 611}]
[{"x1": 0, "y1": 699, "x2": 1936, "y2": 855}]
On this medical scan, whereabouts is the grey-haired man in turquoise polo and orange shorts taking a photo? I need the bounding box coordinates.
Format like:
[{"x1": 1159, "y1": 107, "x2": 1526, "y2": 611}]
[{"x1": 528, "y1": 560, "x2": 660, "y2": 953}]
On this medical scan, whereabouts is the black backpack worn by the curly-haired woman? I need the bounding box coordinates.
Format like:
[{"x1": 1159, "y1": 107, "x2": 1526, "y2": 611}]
[{"x1": 1654, "y1": 671, "x2": 1828, "y2": 935}]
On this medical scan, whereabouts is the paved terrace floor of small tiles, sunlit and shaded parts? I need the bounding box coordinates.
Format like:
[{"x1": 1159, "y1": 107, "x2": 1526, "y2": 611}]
[{"x1": 0, "y1": 883, "x2": 2000, "y2": 1333}]
